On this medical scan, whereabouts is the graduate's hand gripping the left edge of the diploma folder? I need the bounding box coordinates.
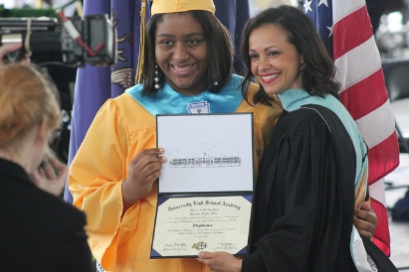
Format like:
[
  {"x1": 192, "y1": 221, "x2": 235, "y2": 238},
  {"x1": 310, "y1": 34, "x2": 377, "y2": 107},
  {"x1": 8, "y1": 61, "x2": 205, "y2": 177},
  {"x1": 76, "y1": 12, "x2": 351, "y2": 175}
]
[{"x1": 122, "y1": 148, "x2": 166, "y2": 211}]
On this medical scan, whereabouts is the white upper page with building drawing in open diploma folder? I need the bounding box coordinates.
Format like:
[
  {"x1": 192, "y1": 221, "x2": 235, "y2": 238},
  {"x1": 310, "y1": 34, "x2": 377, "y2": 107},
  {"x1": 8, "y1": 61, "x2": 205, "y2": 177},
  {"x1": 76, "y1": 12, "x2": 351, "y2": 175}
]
[{"x1": 156, "y1": 113, "x2": 253, "y2": 194}]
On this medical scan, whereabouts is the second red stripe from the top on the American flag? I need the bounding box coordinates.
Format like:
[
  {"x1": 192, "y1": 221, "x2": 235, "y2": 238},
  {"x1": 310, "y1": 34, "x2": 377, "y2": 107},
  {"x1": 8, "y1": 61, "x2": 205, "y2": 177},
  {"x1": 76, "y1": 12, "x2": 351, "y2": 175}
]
[{"x1": 340, "y1": 68, "x2": 388, "y2": 120}]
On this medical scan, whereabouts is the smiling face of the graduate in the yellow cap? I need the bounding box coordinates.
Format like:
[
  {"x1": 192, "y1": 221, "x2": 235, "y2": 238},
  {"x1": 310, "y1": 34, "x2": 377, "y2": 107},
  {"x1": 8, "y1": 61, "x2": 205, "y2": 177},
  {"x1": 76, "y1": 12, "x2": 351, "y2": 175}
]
[{"x1": 155, "y1": 13, "x2": 209, "y2": 95}]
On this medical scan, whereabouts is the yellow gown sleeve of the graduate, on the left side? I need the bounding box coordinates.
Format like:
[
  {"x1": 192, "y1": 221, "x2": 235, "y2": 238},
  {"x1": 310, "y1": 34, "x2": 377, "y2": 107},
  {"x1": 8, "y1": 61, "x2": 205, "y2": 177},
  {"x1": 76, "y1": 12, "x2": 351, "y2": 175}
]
[{"x1": 68, "y1": 99, "x2": 139, "y2": 270}]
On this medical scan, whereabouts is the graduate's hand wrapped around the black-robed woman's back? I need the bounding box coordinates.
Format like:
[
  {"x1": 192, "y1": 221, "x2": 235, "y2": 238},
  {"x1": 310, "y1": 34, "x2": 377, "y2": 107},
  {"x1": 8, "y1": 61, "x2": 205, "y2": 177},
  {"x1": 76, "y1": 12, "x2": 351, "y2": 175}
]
[{"x1": 354, "y1": 202, "x2": 378, "y2": 239}]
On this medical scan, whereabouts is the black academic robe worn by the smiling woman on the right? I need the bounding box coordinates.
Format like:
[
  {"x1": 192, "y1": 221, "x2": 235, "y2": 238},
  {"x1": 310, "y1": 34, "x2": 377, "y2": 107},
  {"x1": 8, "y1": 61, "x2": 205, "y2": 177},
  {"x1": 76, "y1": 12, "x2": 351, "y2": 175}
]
[{"x1": 242, "y1": 105, "x2": 356, "y2": 272}]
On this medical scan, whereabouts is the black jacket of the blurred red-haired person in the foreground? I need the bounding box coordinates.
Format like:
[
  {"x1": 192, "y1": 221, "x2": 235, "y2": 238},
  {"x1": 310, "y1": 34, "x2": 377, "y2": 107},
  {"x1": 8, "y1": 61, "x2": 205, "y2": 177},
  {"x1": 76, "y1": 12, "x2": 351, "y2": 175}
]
[{"x1": 0, "y1": 159, "x2": 94, "y2": 272}]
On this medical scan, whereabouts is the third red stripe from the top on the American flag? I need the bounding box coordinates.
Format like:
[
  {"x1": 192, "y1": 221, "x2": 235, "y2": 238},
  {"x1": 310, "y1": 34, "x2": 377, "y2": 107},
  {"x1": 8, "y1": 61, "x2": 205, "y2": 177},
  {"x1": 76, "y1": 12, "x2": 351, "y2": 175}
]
[{"x1": 368, "y1": 132, "x2": 399, "y2": 185}]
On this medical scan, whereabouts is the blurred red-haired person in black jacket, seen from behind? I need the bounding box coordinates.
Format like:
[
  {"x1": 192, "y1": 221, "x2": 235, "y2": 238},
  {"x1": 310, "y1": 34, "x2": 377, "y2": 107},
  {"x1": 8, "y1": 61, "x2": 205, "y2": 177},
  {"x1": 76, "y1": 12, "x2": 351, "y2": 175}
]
[{"x1": 0, "y1": 61, "x2": 93, "y2": 272}]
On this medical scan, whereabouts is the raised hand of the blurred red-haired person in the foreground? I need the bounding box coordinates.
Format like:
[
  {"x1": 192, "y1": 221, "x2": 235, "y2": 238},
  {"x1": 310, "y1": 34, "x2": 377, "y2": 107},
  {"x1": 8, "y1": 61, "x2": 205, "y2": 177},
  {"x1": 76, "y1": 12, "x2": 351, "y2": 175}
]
[{"x1": 31, "y1": 155, "x2": 68, "y2": 196}]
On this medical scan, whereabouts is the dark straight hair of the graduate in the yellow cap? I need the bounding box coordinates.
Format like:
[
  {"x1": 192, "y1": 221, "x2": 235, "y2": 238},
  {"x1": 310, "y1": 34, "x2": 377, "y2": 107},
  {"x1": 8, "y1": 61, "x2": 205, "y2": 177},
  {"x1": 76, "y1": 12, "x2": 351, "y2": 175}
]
[{"x1": 142, "y1": 10, "x2": 234, "y2": 96}]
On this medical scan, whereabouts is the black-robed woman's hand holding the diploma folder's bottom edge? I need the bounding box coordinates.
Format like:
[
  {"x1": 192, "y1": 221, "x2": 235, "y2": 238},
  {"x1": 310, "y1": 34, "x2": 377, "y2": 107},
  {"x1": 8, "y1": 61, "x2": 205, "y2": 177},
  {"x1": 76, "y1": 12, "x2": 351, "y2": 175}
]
[{"x1": 197, "y1": 251, "x2": 243, "y2": 272}]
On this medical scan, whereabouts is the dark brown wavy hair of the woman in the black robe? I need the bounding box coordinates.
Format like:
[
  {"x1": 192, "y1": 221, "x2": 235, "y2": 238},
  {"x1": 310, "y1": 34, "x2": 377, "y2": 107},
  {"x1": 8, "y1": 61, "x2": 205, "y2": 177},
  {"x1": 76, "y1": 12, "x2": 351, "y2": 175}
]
[{"x1": 240, "y1": 5, "x2": 340, "y2": 103}]
